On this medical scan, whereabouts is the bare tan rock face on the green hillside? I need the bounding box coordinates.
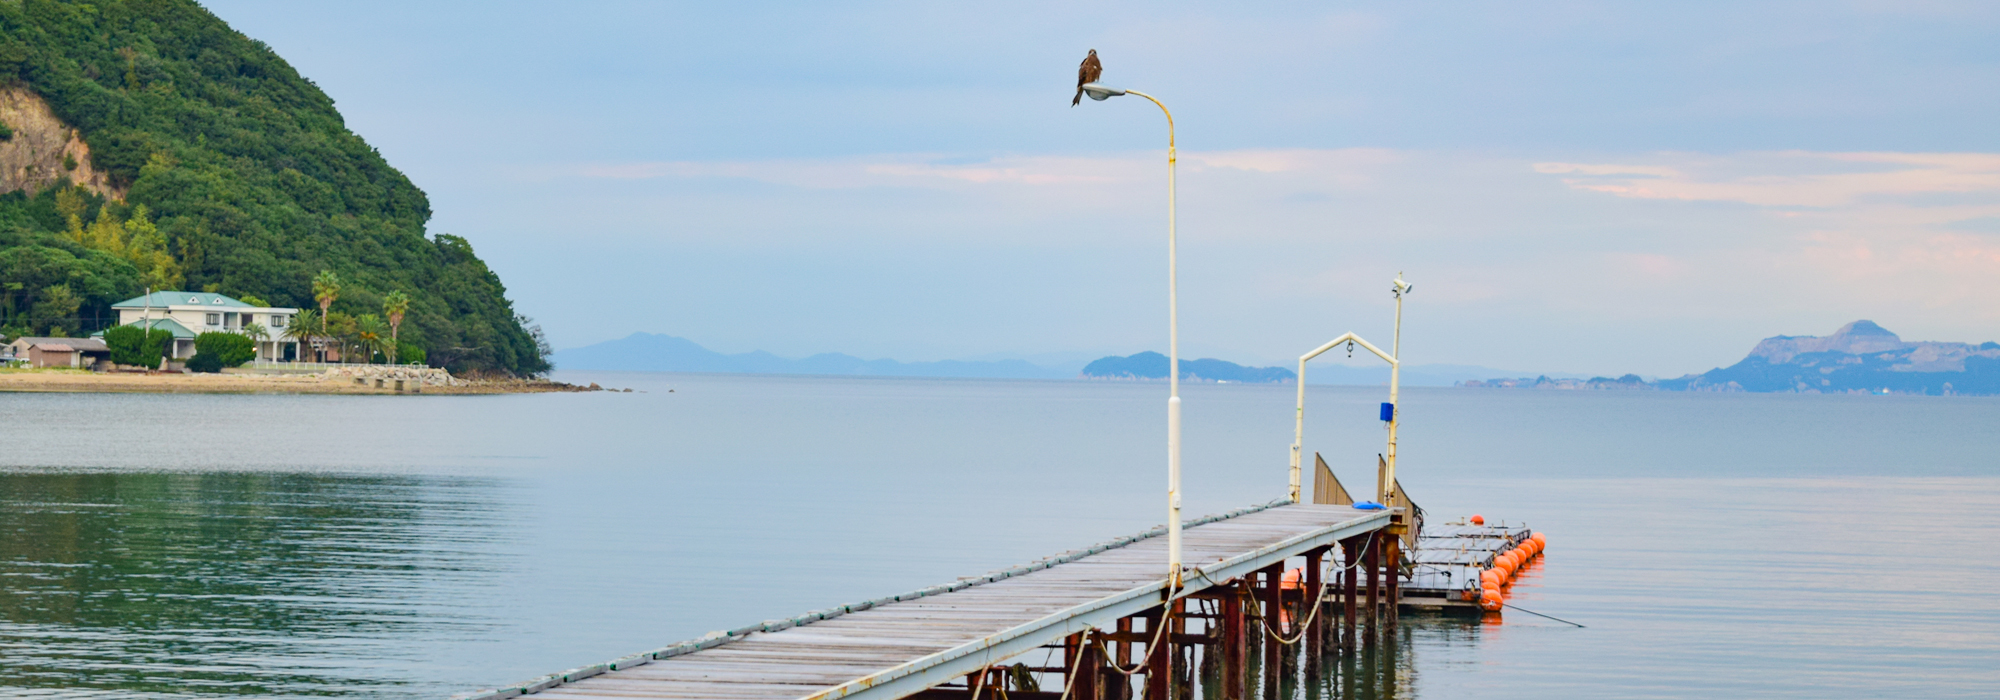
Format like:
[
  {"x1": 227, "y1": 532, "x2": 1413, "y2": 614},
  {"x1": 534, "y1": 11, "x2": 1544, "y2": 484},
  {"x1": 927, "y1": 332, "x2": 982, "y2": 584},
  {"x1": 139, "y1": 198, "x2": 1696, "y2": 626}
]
[{"x1": 0, "y1": 84, "x2": 124, "y2": 200}]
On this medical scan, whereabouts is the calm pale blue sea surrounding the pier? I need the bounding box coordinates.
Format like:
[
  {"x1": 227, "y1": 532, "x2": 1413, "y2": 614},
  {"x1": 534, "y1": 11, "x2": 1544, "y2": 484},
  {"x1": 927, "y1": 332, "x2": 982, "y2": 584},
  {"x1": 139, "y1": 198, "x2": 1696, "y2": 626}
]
[{"x1": 0, "y1": 374, "x2": 2000, "y2": 698}]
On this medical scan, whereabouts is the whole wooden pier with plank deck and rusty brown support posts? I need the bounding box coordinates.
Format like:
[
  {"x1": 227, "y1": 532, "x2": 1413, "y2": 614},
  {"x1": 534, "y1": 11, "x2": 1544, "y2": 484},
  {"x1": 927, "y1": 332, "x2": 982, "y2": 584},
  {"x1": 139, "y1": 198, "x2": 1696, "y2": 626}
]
[{"x1": 458, "y1": 500, "x2": 1410, "y2": 700}]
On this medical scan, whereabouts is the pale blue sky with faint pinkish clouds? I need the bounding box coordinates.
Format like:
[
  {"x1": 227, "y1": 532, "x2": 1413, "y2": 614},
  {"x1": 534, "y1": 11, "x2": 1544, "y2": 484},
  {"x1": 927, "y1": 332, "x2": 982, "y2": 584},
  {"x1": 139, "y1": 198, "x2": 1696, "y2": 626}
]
[{"x1": 206, "y1": 0, "x2": 2000, "y2": 376}]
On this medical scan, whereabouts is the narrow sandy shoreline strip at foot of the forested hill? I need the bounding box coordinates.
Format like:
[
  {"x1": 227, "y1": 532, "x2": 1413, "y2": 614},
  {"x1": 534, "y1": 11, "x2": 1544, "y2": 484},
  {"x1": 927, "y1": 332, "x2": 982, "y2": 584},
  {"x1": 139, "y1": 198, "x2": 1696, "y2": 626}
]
[{"x1": 0, "y1": 370, "x2": 604, "y2": 396}]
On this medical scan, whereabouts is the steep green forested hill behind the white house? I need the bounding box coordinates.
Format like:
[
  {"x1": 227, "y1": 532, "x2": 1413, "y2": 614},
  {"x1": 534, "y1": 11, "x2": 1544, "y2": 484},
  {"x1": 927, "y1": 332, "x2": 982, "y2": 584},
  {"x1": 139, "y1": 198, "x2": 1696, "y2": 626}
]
[{"x1": 0, "y1": 0, "x2": 548, "y2": 374}]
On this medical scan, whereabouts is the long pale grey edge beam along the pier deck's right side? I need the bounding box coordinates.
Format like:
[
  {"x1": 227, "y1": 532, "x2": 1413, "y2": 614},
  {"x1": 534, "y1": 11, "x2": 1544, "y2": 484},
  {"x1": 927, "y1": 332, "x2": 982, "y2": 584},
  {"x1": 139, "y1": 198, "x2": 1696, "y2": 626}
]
[{"x1": 800, "y1": 510, "x2": 1392, "y2": 700}]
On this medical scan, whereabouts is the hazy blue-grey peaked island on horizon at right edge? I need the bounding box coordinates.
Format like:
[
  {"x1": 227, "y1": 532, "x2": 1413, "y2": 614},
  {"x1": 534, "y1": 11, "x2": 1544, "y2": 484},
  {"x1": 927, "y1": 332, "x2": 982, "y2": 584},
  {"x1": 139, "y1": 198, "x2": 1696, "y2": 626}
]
[{"x1": 1458, "y1": 320, "x2": 2000, "y2": 396}]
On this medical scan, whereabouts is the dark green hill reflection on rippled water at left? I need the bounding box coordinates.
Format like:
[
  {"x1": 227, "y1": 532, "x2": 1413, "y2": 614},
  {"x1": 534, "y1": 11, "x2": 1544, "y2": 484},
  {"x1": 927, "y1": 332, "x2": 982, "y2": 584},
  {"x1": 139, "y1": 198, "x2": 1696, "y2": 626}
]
[{"x1": 0, "y1": 472, "x2": 508, "y2": 696}]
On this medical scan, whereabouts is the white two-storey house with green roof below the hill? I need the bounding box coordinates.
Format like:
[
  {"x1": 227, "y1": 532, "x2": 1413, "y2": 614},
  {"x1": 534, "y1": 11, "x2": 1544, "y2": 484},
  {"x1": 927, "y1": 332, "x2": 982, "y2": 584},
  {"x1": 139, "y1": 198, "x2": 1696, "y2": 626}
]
[{"x1": 112, "y1": 292, "x2": 298, "y2": 362}]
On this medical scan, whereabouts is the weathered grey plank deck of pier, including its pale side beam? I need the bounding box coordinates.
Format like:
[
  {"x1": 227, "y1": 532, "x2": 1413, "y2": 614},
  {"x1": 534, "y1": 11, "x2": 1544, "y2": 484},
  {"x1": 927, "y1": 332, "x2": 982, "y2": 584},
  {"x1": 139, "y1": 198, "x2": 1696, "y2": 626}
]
[{"x1": 460, "y1": 504, "x2": 1392, "y2": 700}]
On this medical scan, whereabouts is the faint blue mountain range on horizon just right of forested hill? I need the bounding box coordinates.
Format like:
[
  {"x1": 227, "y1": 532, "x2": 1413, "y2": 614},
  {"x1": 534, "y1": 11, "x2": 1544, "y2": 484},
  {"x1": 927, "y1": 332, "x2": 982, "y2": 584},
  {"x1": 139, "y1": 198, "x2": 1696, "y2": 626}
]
[{"x1": 556, "y1": 332, "x2": 1074, "y2": 380}]
